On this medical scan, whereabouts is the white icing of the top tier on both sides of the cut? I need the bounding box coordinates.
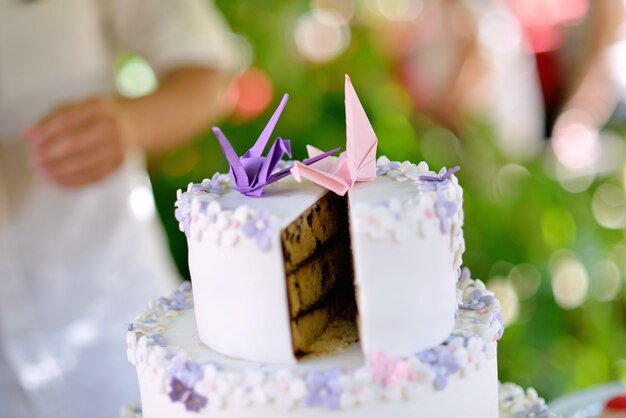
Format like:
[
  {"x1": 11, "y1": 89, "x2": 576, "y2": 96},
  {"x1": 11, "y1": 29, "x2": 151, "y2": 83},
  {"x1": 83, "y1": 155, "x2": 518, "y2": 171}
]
[{"x1": 177, "y1": 157, "x2": 464, "y2": 363}]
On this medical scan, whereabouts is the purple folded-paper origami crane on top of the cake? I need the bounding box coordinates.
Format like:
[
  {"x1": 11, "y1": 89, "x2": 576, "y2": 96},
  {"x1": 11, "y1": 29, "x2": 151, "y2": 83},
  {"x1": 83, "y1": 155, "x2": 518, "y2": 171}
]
[{"x1": 213, "y1": 94, "x2": 339, "y2": 197}]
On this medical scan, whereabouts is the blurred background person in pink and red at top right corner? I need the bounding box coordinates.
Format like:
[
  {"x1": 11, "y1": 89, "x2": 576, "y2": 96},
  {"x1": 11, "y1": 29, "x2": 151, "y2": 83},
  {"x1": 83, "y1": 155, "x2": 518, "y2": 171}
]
[{"x1": 507, "y1": 0, "x2": 624, "y2": 141}]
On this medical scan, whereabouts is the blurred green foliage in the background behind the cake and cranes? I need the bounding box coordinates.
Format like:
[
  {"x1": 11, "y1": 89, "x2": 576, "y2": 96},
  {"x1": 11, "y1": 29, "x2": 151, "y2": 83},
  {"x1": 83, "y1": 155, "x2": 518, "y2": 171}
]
[{"x1": 144, "y1": 0, "x2": 626, "y2": 399}]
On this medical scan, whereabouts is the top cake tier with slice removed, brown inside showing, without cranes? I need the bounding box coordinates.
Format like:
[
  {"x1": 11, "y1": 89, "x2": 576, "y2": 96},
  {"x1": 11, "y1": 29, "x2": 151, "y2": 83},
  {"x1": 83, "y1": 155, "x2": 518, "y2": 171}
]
[{"x1": 177, "y1": 157, "x2": 464, "y2": 363}]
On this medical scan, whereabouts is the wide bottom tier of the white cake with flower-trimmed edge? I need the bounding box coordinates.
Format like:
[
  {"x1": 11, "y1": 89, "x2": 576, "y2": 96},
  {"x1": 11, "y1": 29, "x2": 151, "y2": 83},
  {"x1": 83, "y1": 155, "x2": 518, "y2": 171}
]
[{"x1": 127, "y1": 272, "x2": 512, "y2": 418}]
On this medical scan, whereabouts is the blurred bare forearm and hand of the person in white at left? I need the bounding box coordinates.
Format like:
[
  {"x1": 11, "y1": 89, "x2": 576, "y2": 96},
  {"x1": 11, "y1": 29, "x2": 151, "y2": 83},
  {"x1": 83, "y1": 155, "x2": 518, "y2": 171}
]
[{"x1": 24, "y1": 67, "x2": 226, "y2": 187}]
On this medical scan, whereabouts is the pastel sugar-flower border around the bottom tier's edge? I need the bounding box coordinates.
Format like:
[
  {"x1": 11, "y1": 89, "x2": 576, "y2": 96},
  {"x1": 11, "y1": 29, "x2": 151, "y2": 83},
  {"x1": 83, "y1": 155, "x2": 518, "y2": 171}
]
[{"x1": 126, "y1": 269, "x2": 504, "y2": 412}]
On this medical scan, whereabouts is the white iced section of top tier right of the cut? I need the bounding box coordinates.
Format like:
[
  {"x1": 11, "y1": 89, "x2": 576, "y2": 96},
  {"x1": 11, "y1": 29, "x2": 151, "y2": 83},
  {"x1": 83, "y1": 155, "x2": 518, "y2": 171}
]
[{"x1": 348, "y1": 162, "x2": 464, "y2": 357}]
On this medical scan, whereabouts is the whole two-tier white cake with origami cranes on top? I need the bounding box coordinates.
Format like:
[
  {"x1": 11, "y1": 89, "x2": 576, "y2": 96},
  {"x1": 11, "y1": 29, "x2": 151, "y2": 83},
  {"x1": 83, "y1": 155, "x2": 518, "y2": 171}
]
[{"x1": 127, "y1": 79, "x2": 550, "y2": 418}]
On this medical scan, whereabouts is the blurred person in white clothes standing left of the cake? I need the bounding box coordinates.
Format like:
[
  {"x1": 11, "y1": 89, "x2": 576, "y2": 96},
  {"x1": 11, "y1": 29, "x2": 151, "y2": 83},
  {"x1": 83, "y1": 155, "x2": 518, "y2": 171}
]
[{"x1": 0, "y1": 0, "x2": 236, "y2": 418}]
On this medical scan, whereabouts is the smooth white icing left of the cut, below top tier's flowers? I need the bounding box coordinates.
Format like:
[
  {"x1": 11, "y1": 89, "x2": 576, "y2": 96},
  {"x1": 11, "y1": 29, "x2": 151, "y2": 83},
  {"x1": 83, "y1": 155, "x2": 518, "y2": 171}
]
[{"x1": 189, "y1": 235, "x2": 296, "y2": 363}]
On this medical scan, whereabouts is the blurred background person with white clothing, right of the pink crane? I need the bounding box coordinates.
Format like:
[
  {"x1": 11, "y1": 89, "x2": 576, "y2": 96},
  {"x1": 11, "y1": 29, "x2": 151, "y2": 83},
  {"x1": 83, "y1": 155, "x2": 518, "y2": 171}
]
[{"x1": 368, "y1": 0, "x2": 542, "y2": 159}]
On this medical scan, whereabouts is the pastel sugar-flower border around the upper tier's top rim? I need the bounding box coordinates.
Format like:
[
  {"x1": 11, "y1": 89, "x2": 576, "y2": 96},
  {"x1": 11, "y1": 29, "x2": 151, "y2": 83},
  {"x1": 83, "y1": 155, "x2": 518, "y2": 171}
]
[{"x1": 175, "y1": 156, "x2": 465, "y2": 268}]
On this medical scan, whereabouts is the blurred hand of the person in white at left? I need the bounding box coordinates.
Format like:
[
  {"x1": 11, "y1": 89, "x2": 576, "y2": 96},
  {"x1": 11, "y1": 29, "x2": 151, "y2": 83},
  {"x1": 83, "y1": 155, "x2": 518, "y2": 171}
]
[{"x1": 24, "y1": 98, "x2": 128, "y2": 187}]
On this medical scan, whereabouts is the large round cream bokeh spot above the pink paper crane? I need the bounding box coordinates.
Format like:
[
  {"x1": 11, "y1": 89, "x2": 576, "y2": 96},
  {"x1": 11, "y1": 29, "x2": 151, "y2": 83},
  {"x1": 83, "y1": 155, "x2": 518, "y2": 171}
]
[{"x1": 295, "y1": 9, "x2": 350, "y2": 63}]
